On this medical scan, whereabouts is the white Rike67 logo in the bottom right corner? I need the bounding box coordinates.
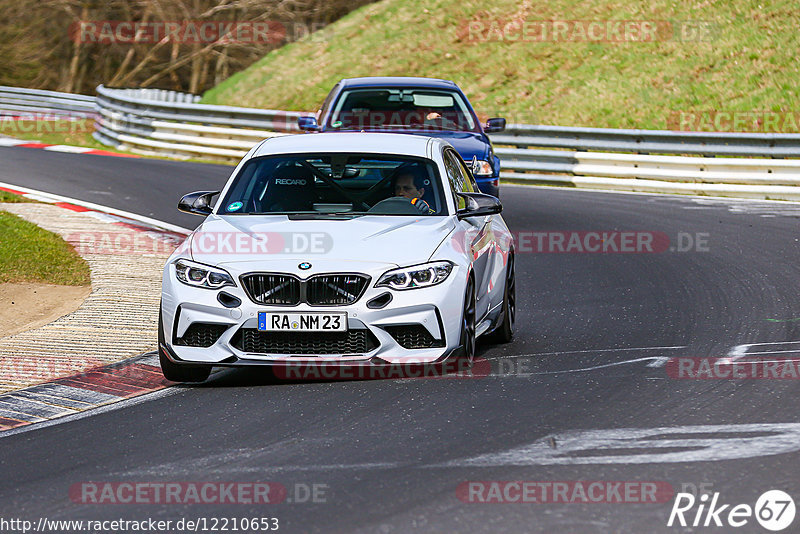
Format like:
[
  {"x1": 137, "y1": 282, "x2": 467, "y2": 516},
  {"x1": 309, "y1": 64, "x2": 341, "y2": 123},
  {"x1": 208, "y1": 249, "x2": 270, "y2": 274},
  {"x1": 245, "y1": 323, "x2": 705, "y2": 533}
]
[{"x1": 667, "y1": 490, "x2": 795, "y2": 532}]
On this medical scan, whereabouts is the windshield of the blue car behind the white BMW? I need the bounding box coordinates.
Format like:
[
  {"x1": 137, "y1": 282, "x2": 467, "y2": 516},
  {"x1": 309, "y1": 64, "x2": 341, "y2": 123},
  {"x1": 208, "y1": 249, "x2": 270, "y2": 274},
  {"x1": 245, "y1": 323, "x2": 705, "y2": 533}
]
[{"x1": 327, "y1": 88, "x2": 479, "y2": 132}]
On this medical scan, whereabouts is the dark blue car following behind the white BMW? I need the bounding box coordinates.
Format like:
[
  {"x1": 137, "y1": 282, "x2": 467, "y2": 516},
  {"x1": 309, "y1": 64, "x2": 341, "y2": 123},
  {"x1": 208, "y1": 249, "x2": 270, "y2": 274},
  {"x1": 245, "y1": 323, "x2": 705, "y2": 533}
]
[{"x1": 298, "y1": 77, "x2": 506, "y2": 197}]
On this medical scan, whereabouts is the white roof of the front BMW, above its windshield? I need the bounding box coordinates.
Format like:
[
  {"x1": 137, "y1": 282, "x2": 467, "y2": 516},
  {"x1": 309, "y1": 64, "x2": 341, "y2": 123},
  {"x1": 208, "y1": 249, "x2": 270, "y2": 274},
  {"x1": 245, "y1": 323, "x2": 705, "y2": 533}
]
[{"x1": 252, "y1": 132, "x2": 448, "y2": 158}]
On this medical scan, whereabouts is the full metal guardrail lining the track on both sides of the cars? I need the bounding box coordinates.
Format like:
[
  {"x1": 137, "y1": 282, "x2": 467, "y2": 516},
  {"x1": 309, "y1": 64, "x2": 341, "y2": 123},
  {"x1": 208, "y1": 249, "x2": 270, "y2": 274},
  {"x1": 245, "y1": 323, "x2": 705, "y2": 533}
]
[{"x1": 0, "y1": 85, "x2": 800, "y2": 200}]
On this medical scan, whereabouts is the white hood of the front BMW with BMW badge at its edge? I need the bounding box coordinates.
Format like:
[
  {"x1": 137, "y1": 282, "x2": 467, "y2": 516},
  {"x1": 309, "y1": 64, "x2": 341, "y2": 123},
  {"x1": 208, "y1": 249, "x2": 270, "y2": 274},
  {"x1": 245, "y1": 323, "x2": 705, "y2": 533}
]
[{"x1": 186, "y1": 215, "x2": 455, "y2": 267}]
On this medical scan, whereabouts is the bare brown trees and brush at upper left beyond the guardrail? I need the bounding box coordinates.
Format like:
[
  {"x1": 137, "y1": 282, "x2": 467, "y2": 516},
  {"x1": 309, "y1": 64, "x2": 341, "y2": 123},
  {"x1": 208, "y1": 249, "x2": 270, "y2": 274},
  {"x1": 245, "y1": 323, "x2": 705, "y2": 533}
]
[{"x1": 0, "y1": 0, "x2": 375, "y2": 93}]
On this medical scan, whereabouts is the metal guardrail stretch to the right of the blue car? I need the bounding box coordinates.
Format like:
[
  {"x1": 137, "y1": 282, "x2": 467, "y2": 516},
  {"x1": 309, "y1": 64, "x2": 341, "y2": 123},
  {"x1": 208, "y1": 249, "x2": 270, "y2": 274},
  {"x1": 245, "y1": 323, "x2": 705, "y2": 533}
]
[{"x1": 490, "y1": 124, "x2": 800, "y2": 200}]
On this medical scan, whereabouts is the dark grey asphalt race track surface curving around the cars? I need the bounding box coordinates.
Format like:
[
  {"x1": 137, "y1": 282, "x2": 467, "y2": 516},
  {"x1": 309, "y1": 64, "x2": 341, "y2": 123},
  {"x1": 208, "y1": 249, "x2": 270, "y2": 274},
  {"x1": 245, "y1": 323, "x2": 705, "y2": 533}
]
[{"x1": 0, "y1": 148, "x2": 800, "y2": 533}]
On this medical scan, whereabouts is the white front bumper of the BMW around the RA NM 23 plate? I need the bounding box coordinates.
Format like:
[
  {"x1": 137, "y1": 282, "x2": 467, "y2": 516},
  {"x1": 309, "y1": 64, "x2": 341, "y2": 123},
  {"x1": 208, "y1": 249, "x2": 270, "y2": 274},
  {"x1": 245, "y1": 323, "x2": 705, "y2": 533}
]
[{"x1": 160, "y1": 263, "x2": 467, "y2": 366}]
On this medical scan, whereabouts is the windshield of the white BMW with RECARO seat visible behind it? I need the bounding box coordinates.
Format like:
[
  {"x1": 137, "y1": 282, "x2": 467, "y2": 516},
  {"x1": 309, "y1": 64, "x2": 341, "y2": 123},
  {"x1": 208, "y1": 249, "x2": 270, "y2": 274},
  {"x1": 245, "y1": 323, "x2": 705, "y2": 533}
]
[{"x1": 217, "y1": 153, "x2": 447, "y2": 216}]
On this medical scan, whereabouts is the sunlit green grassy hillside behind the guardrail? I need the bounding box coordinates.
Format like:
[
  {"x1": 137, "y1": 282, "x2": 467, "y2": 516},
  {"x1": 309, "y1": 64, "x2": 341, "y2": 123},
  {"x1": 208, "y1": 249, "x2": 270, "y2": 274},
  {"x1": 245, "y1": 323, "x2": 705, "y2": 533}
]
[{"x1": 203, "y1": 0, "x2": 800, "y2": 129}]
